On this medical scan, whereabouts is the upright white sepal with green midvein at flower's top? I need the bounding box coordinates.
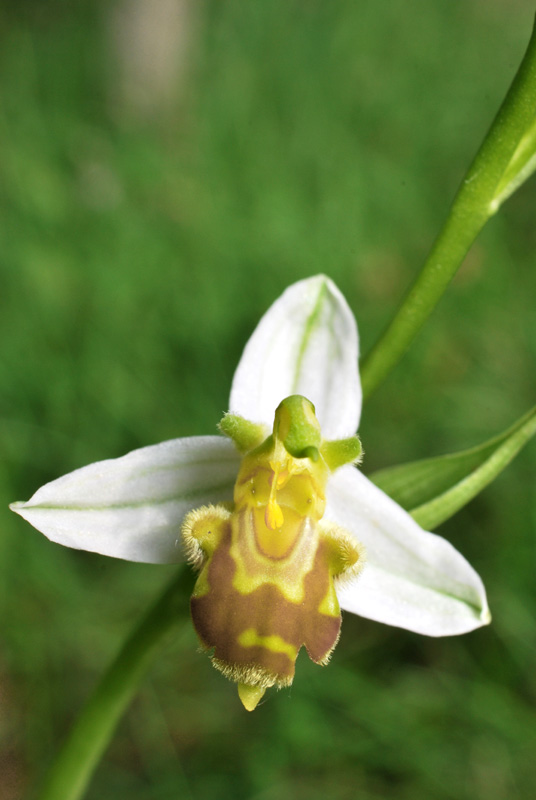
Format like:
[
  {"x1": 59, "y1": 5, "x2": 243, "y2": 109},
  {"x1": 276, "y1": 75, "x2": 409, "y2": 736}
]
[{"x1": 230, "y1": 275, "x2": 362, "y2": 439}]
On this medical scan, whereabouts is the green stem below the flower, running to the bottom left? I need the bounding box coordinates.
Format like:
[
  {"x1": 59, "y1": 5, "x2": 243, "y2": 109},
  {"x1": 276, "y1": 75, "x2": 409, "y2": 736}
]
[{"x1": 39, "y1": 569, "x2": 188, "y2": 800}]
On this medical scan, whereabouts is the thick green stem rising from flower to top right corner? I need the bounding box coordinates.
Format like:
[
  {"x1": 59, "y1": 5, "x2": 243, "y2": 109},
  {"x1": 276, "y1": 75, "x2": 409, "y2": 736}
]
[{"x1": 361, "y1": 20, "x2": 536, "y2": 397}]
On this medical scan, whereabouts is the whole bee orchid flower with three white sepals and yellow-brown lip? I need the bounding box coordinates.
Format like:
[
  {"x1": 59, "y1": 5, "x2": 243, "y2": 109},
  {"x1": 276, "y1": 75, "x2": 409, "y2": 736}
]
[{"x1": 11, "y1": 275, "x2": 490, "y2": 710}]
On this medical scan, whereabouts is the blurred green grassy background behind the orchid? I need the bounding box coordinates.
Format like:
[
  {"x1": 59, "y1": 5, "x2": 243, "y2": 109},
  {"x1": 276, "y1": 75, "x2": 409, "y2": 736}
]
[{"x1": 0, "y1": 0, "x2": 536, "y2": 800}]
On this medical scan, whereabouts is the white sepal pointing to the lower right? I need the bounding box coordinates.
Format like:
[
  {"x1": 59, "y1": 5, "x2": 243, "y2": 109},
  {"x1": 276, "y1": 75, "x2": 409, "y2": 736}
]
[{"x1": 325, "y1": 466, "x2": 490, "y2": 636}]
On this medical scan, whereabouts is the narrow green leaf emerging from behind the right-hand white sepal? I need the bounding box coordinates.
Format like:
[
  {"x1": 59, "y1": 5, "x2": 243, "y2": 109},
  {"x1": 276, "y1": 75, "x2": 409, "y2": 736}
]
[{"x1": 370, "y1": 406, "x2": 536, "y2": 530}]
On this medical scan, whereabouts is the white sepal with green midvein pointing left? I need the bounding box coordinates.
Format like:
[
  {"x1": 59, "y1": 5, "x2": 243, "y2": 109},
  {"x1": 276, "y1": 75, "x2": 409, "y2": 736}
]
[{"x1": 11, "y1": 436, "x2": 239, "y2": 564}]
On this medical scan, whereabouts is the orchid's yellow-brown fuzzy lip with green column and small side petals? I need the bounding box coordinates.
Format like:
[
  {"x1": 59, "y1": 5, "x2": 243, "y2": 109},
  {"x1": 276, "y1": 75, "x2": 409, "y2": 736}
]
[{"x1": 182, "y1": 395, "x2": 364, "y2": 711}]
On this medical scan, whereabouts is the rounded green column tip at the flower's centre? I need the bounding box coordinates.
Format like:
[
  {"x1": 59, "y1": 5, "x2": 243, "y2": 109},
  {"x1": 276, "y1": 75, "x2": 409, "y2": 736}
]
[{"x1": 274, "y1": 394, "x2": 322, "y2": 461}]
